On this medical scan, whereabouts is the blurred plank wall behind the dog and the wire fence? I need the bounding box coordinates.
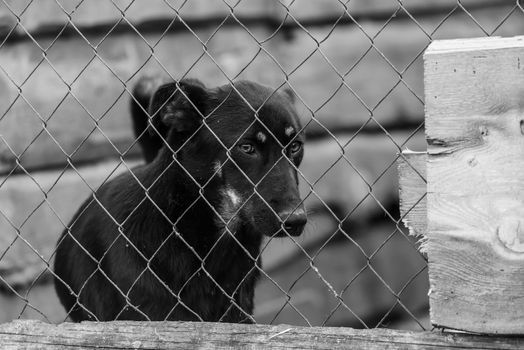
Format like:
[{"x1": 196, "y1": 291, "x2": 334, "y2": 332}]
[{"x1": 0, "y1": 0, "x2": 524, "y2": 330}]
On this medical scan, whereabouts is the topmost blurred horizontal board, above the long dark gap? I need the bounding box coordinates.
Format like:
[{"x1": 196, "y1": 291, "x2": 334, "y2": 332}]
[{"x1": 0, "y1": 0, "x2": 513, "y2": 43}]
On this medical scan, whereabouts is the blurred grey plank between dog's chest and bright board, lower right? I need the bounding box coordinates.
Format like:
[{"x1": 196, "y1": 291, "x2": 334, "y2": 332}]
[{"x1": 255, "y1": 222, "x2": 431, "y2": 330}]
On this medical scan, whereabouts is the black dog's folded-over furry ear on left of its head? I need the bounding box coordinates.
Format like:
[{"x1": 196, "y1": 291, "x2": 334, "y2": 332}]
[{"x1": 149, "y1": 79, "x2": 209, "y2": 133}]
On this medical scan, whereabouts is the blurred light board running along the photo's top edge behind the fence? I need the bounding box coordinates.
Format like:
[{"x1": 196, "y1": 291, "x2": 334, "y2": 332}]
[{"x1": 0, "y1": 0, "x2": 512, "y2": 35}]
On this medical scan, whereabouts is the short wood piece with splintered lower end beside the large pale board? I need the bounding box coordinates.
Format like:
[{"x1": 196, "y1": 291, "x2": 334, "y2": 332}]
[{"x1": 397, "y1": 151, "x2": 428, "y2": 238}]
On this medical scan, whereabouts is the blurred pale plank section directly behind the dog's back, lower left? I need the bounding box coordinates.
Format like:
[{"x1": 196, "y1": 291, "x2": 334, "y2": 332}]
[{"x1": 0, "y1": 162, "x2": 136, "y2": 289}]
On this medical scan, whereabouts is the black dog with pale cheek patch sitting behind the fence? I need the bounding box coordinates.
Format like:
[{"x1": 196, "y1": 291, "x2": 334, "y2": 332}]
[{"x1": 55, "y1": 76, "x2": 306, "y2": 322}]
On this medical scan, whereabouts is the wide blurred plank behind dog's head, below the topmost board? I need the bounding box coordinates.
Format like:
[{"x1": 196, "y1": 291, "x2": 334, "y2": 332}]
[{"x1": 0, "y1": 2, "x2": 524, "y2": 173}]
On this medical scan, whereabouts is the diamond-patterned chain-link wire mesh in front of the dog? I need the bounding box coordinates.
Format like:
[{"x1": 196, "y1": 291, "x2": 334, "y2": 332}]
[{"x1": 0, "y1": 0, "x2": 524, "y2": 330}]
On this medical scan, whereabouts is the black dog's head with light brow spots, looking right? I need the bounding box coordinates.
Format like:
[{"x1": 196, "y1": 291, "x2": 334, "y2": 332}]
[{"x1": 150, "y1": 80, "x2": 306, "y2": 236}]
